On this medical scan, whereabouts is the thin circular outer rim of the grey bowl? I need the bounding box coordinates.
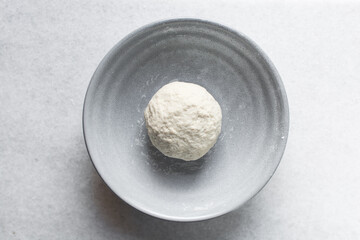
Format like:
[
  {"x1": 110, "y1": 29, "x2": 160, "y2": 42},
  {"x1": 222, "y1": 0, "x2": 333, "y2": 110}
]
[{"x1": 82, "y1": 18, "x2": 290, "y2": 222}]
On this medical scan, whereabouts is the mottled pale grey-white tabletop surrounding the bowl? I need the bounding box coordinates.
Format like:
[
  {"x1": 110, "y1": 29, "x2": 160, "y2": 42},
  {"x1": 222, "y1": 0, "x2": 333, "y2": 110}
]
[{"x1": 0, "y1": 0, "x2": 360, "y2": 240}]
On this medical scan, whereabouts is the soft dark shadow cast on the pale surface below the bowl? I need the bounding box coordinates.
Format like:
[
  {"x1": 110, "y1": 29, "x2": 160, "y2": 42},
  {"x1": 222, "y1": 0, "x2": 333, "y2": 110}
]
[{"x1": 94, "y1": 168, "x2": 258, "y2": 240}]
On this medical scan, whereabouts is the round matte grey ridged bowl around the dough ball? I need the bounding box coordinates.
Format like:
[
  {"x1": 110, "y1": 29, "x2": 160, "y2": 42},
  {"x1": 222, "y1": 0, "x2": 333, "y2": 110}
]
[{"x1": 83, "y1": 19, "x2": 289, "y2": 221}]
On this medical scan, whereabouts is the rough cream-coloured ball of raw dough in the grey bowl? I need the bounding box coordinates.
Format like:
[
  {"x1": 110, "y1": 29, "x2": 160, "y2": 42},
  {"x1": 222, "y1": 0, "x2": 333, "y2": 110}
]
[{"x1": 144, "y1": 82, "x2": 222, "y2": 161}]
